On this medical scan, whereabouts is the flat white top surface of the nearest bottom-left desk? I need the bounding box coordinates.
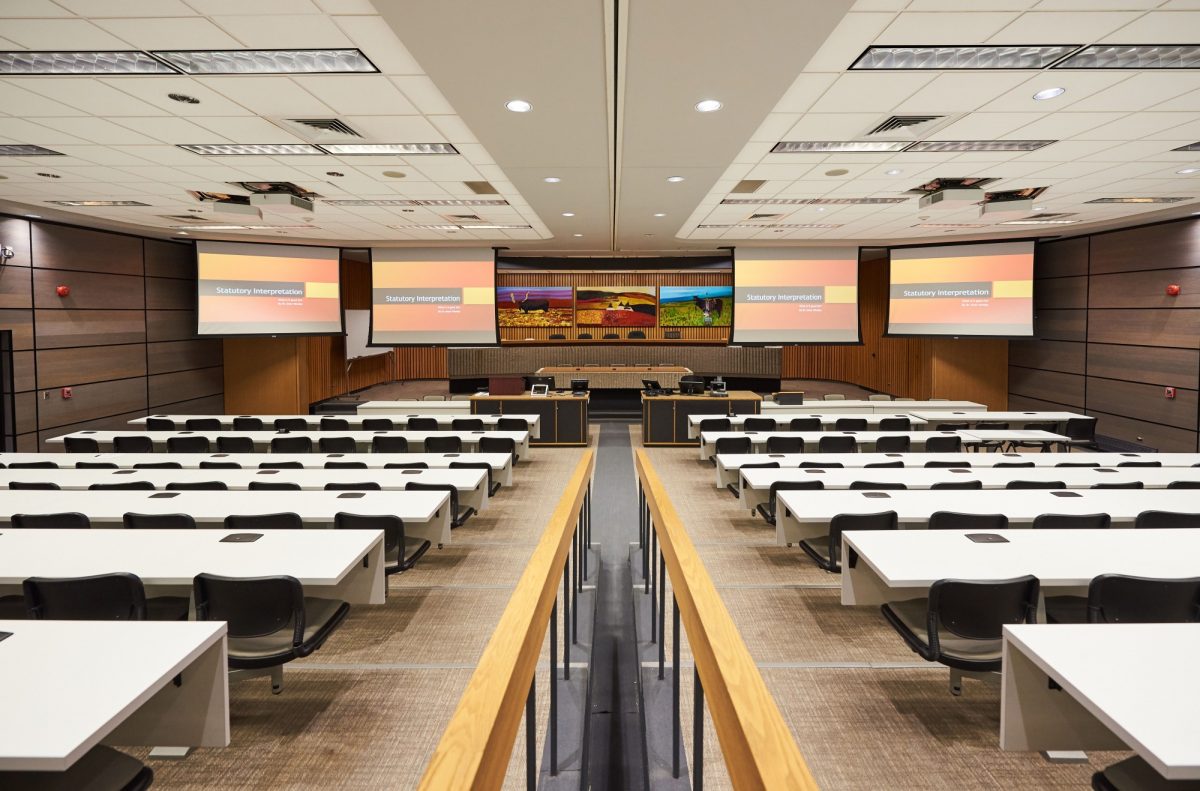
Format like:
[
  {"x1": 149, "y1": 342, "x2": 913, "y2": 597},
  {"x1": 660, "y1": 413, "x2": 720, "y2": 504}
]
[{"x1": 0, "y1": 624, "x2": 226, "y2": 771}]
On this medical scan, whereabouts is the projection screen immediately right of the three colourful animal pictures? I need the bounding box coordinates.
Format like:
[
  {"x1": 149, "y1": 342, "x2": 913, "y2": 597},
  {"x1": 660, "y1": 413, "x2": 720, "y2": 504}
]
[{"x1": 732, "y1": 247, "x2": 859, "y2": 344}]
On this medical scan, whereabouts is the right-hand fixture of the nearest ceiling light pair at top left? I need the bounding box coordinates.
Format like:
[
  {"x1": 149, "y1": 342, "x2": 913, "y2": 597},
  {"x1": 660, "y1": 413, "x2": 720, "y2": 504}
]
[{"x1": 151, "y1": 49, "x2": 379, "y2": 74}]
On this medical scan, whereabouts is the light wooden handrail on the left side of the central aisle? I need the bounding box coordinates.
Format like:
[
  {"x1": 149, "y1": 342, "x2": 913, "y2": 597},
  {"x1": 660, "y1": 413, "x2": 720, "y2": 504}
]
[{"x1": 418, "y1": 450, "x2": 595, "y2": 791}]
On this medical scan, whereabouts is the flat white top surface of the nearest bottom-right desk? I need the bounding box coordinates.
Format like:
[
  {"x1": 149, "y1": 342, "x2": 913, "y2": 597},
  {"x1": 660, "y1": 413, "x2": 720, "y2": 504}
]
[{"x1": 1004, "y1": 623, "x2": 1200, "y2": 780}]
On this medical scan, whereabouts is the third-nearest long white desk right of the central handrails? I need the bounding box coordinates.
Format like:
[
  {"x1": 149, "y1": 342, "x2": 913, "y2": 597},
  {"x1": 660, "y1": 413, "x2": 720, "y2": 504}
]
[{"x1": 775, "y1": 489, "x2": 1200, "y2": 549}]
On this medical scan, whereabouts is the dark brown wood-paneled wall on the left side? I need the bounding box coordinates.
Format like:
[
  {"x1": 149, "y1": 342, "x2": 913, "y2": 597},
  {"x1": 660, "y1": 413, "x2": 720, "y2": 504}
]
[{"x1": 0, "y1": 217, "x2": 224, "y2": 450}]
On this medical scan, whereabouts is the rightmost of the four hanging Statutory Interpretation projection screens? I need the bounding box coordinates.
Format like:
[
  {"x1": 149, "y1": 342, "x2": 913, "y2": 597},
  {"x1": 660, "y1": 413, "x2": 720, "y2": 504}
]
[{"x1": 888, "y1": 241, "x2": 1033, "y2": 337}]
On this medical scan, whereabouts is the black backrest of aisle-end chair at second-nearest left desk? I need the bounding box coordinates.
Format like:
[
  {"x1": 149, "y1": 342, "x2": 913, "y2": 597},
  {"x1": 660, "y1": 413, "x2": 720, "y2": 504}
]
[{"x1": 192, "y1": 574, "x2": 305, "y2": 646}]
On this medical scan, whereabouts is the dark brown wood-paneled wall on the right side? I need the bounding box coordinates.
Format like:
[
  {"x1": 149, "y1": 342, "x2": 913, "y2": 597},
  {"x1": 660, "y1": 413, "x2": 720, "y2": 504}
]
[{"x1": 1009, "y1": 218, "x2": 1200, "y2": 451}]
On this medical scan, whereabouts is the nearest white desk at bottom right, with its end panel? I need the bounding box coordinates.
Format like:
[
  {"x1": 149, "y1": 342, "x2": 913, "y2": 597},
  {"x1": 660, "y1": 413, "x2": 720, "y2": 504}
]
[{"x1": 1000, "y1": 623, "x2": 1200, "y2": 789}]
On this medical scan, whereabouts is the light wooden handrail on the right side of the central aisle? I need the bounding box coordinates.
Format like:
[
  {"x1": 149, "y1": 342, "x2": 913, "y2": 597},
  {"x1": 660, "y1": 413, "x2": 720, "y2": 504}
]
[{"x1": 636, "y1": 450, "x2": 817, "y2": 791}]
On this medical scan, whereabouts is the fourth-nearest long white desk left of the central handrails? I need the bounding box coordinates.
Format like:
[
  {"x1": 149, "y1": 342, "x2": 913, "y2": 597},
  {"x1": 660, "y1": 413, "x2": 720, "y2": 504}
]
[{"x1": 0, "y1": 468, "x2": 488, "y2": 511}]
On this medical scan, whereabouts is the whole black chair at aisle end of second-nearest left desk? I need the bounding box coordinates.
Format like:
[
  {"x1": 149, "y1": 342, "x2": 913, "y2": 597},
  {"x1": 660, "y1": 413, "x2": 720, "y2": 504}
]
[{"x1": 192, "y1": 574, "x2": 350, "y2": 695}]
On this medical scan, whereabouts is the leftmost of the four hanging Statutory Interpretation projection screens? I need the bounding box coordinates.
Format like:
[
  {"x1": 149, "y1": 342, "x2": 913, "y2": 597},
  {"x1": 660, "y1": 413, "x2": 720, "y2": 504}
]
[{"x1": 196, "y1": 241, "x2": 343, "y2": 335}]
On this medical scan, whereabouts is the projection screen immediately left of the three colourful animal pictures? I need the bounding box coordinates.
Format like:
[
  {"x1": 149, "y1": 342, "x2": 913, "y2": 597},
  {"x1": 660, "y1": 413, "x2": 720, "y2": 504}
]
[{"x1": 371, "y1": 247, "x2": 499, "y2": 346}]
